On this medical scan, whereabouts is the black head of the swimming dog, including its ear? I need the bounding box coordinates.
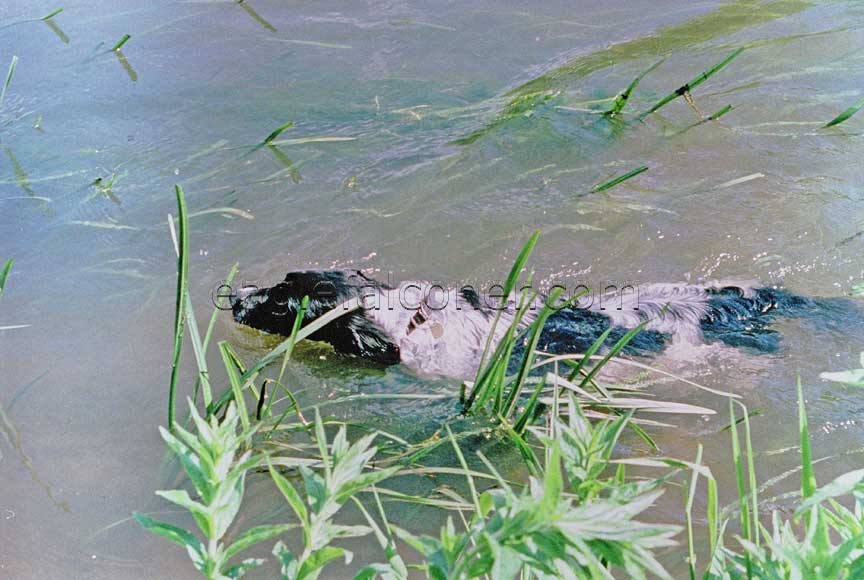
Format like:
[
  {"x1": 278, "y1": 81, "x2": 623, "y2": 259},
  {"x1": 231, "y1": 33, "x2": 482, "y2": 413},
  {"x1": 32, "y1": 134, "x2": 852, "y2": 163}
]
[{"x1": 231, "y1": 270, "x2": 399, "y2": 364}]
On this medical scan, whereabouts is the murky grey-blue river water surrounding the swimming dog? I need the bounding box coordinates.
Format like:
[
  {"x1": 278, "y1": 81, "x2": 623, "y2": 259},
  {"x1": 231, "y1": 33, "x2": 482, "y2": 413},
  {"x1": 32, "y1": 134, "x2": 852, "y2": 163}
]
[{"x1": 0, "y1": 0, "x2": 864, "y2": 578}]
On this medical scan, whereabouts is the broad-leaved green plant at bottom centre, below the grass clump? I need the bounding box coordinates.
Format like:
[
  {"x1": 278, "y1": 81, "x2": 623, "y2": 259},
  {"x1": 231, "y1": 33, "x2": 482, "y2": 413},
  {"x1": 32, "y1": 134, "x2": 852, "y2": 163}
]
[{"x1": 394, "y1": 420, "x2": 679, "y2": 579}]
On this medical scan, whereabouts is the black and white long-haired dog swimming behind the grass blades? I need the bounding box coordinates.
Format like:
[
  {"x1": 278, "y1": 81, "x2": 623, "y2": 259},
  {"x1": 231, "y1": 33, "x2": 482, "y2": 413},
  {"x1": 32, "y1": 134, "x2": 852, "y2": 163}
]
[{"x1": 232, "y1": 270, "x2": 819, "y2": 379}]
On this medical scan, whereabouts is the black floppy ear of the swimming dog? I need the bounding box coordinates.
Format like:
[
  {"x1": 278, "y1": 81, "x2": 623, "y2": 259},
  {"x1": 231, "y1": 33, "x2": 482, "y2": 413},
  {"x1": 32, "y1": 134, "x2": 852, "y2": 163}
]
[{"x1": 309, "y1": 313, "x2": 401, "y2": 365}]
